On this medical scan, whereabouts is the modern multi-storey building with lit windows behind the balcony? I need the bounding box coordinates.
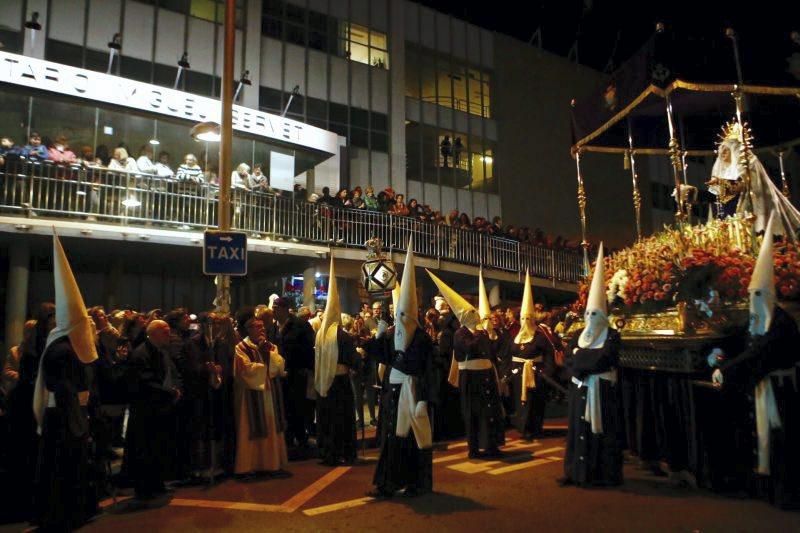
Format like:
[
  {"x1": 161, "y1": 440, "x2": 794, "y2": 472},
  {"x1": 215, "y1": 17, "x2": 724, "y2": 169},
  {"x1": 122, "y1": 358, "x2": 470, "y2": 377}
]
[{"x1": 0, "y1": 0, "x2": 634, "y2": 350}]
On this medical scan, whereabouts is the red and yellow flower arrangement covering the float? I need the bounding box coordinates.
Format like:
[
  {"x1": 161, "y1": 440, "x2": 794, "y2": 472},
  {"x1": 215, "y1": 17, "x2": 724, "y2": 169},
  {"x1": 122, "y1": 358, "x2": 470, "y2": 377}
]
[{"x1": 573, "y1": 216, "x2": 800, "y2": 315}]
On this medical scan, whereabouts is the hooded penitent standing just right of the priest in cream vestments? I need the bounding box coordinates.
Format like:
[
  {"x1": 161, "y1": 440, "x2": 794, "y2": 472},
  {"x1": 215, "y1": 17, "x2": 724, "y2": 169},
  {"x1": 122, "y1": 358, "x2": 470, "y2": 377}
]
[{"x1": 314, "y1": 257, "x2": 357, "y2": 466}]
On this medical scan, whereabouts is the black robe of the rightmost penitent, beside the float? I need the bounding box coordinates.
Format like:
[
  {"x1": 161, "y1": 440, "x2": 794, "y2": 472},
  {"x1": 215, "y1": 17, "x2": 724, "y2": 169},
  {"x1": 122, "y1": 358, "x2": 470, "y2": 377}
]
[{"x1": 720, "y1": 307, "x2": 800, "y2": 508}]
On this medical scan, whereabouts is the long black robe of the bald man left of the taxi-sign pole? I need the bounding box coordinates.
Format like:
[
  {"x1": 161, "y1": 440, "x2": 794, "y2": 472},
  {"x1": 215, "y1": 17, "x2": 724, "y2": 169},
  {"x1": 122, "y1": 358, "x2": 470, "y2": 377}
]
[{"x1": 126, "y1": 340, "x2": 181, "y2": 498}]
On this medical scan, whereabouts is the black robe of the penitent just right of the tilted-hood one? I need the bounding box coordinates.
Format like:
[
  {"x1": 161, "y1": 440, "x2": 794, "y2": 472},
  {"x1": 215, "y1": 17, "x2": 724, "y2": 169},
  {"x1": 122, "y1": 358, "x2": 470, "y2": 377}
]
[{"x1": 506, "y1": 326, "x2": 560, "y2": 438}]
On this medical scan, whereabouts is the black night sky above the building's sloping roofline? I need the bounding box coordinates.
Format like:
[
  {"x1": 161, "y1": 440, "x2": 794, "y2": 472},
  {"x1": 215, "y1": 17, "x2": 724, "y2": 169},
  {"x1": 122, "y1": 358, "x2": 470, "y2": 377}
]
[{"x1": 418, "y1": 0, "x2": 800, "y2": 78}]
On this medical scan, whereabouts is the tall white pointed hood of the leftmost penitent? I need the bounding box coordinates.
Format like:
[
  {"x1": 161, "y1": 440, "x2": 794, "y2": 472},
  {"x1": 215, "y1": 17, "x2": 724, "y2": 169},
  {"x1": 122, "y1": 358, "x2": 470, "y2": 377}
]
[{"x1": 33, "y1": 235, "x2": 97, "y2": 431}]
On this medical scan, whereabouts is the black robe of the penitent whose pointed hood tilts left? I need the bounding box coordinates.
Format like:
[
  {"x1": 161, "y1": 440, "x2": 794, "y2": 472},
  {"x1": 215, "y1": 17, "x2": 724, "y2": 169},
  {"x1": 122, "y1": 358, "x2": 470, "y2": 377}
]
[{"x1": 453, "y1": 327, "x2": 505, "y2": 454}]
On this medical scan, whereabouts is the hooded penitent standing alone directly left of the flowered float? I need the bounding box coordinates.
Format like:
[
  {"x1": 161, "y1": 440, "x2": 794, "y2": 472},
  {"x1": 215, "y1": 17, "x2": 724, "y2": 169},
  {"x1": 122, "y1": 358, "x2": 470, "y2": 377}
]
[{"x1": 559, "y1": 244, "x2": 622, "y2": 486}]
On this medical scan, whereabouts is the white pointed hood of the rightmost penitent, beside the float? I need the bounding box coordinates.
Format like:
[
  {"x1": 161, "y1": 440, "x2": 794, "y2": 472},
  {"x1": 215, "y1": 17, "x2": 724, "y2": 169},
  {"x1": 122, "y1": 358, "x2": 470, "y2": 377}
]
[{"x1": 747, "y1": 214, "x2": 777, "y2": 335}]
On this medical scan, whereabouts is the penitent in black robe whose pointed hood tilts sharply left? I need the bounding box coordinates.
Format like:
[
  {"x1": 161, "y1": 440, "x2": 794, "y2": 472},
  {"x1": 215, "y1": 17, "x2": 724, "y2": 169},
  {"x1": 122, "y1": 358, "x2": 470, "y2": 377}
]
[{"x1": 428, "y1": 271, "x2": 505, "y2": 459}]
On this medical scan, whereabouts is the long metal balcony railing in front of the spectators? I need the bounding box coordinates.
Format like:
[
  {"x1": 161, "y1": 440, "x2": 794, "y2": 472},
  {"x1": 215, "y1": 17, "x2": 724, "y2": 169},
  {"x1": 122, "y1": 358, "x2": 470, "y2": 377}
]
[{"x1": 0, "y1": 161, "x2": 583, "y2": 282}]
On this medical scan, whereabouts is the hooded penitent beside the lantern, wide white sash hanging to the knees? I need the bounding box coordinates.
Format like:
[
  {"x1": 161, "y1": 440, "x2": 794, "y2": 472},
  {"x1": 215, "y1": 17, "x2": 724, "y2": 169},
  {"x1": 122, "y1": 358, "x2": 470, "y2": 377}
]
[{"x1": 369, "y1": 241, "x2": 434, "y2": 498}]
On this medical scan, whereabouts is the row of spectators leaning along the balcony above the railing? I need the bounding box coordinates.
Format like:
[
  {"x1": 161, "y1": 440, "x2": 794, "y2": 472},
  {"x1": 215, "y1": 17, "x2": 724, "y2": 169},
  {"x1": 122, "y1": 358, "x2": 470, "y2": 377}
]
[{"x1": 0, "y1": 132, "x2": 580, "y2": 250}]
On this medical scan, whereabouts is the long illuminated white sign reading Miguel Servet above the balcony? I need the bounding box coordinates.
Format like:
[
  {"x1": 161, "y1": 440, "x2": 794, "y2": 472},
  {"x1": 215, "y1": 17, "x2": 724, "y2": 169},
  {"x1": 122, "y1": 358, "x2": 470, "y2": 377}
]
[{"x1": 0, "y1": 52, "x2": 339, "y2": 154}]
